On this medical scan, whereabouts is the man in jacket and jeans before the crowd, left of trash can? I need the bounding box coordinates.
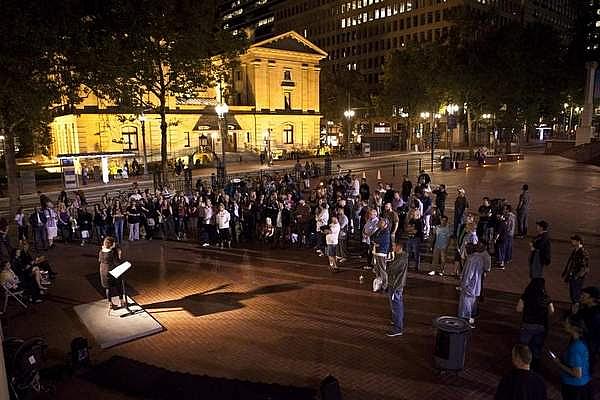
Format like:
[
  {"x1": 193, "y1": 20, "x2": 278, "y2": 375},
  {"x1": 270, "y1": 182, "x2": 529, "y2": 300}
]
[{"x1": 387, "y1": 243, "x2": 408, "y2": 337}]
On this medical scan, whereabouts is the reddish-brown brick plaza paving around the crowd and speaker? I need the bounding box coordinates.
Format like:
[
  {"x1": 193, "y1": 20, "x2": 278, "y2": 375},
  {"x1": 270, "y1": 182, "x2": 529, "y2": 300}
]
[{"x1": 4, "y1": 154, "x2": 600, "y2": 400}]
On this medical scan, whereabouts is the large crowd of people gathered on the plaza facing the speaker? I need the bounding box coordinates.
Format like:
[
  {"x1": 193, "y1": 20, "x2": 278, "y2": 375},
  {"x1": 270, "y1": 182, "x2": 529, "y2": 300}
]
[{"x1": 2, "y1": 165, "x2": 600, "y2": 399}]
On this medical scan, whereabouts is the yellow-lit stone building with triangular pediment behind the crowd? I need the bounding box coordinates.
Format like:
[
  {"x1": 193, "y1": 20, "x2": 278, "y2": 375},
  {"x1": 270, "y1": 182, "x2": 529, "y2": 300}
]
[{"x1": 50, "y1": 32, "x2": 327, "y2": 174}]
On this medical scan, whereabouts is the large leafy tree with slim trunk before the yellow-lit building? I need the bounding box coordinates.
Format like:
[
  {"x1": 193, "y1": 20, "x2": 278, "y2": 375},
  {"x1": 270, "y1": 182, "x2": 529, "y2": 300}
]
[{"x1": 72, "y1": 0, "x2": 245, "y2": 171}]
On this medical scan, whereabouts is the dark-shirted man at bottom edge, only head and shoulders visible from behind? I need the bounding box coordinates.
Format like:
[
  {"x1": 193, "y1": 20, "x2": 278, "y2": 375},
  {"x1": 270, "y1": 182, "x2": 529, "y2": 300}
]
[{"x1": 494, "y1": 344, "x2": 547, "y2": 400}]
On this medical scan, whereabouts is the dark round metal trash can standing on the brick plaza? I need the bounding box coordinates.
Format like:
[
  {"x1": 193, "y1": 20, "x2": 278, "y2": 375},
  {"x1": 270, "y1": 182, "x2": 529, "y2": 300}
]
[{"x1": 433, "y1": 316, "x2": 471, "y2": 371}]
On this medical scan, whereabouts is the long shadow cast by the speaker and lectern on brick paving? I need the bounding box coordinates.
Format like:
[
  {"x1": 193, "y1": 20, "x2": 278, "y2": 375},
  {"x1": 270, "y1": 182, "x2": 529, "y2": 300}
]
[{"x1": 143, "y1": 283, "x2": 308, "y2": 317}]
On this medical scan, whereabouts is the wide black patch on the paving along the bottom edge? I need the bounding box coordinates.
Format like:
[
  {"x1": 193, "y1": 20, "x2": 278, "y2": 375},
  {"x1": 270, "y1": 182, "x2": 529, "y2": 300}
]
[{"x1": 83, "y1": 356, "x2": 315, "y2": 400}]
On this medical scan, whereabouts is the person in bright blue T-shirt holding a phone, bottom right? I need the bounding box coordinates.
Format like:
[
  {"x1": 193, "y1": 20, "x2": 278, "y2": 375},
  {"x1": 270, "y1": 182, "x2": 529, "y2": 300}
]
[{"x1": 548, "y1": 315, "x2": 593, "y2": 400}]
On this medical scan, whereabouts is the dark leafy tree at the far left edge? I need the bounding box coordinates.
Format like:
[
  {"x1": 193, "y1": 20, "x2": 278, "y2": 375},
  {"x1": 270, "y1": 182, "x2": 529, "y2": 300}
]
[{"x1": 0, "y1": 0, "x2": 71, "y2": 212}]
